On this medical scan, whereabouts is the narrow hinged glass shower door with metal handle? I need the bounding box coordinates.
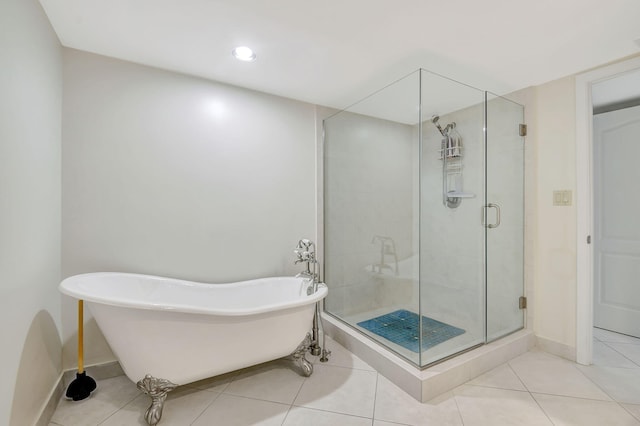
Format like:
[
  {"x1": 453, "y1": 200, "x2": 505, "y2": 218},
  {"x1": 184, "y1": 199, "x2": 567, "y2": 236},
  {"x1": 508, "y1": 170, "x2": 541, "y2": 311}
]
[{"x1": 484, "y1": 93, "x2": 525, "y2": 342}]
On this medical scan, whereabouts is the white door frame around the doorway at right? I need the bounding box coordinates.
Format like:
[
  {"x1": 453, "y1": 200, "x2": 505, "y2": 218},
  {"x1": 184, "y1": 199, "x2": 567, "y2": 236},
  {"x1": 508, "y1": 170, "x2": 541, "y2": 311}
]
[{"x1": 576, "y1": 57, "x2": 640, "y2": 365}]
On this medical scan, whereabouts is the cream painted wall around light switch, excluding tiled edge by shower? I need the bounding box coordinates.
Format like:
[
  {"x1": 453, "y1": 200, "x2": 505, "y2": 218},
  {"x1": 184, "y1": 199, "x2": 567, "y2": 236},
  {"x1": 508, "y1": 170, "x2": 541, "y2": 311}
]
[{"x1": 531, "y1": 77, "x2": 576, "y2": 358}]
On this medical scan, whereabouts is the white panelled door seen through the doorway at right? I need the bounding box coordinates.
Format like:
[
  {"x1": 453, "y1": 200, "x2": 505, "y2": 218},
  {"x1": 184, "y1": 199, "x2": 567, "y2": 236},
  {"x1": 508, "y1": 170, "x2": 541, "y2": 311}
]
[{"x1": 593, "y1": 106, "x2": 640, "y2": 337}]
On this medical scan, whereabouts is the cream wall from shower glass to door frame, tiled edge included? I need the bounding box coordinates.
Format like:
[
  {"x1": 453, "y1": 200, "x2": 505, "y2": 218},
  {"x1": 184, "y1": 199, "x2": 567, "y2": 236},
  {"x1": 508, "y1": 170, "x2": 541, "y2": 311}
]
[{"x1": 484, "y1": 76, "x2": 577, "y2": 359}]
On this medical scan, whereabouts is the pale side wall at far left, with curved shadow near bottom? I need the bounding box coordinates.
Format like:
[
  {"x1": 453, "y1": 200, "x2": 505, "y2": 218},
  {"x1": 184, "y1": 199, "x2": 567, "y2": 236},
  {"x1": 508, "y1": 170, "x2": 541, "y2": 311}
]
[{"x1": 0, "y1": 0, "x2": 62, "y2": 425}]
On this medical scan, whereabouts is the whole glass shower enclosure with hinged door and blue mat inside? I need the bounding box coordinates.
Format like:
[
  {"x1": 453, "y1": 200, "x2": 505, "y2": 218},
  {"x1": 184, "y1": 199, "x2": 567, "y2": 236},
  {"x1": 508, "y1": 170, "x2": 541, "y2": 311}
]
[{"x1": 322, "y1": 69, "x2": 524, "y2": 367}]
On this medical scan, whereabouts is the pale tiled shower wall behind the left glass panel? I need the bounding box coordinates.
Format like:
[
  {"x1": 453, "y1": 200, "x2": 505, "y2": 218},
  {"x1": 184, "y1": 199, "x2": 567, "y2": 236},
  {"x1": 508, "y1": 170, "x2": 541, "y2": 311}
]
[{"x1": 324, "y1": 112, "x2": 417, "y2": 316}]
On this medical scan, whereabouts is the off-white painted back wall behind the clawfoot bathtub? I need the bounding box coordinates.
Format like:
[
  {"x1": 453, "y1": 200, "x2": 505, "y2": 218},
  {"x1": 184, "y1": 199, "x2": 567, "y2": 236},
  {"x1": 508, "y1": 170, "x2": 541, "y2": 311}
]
[{"x1": 62, "y1": 49, "x2": 316, "y2": 367}]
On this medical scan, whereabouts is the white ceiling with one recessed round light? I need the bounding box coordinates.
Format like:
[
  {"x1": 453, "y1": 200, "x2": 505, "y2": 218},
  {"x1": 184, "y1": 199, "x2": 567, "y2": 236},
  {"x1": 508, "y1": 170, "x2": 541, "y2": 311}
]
[{"x1": 40, "y1": 0, "x2": 640, "y2": 108}]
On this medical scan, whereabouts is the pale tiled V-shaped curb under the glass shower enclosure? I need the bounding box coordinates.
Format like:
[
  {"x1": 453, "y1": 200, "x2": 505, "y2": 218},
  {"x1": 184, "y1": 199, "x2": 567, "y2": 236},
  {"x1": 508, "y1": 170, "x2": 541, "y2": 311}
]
[{"x1": 322, "y1": 313, "x2": 536, "y2": 402}]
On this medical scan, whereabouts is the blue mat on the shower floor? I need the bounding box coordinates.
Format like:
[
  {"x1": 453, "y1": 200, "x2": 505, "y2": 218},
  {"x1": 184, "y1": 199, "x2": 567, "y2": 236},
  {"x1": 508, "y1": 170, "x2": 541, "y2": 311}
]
[{"x1": 358, "y1": 309, "x2": 464, "y2": 352}]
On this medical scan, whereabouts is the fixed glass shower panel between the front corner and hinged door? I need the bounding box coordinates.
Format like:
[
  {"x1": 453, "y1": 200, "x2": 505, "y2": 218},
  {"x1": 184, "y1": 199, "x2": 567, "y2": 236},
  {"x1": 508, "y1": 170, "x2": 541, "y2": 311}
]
[{"x1": 420, "y1": 70, "x2": 485, "y2": 366}]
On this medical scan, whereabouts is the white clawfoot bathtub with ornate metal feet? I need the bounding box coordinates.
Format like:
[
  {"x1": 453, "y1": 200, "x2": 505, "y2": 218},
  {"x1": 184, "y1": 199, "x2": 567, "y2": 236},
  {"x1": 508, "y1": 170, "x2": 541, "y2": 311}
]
[{"x1": 60, "y1": 272, "x2": 327, "y2": 425}]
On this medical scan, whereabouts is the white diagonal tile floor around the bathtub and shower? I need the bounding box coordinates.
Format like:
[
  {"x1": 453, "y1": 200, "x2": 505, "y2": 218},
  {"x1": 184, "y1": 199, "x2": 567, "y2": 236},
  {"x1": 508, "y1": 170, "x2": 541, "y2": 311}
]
[{"x1": 50, "y1": 329, "x2": 640, "y2": 426}]
